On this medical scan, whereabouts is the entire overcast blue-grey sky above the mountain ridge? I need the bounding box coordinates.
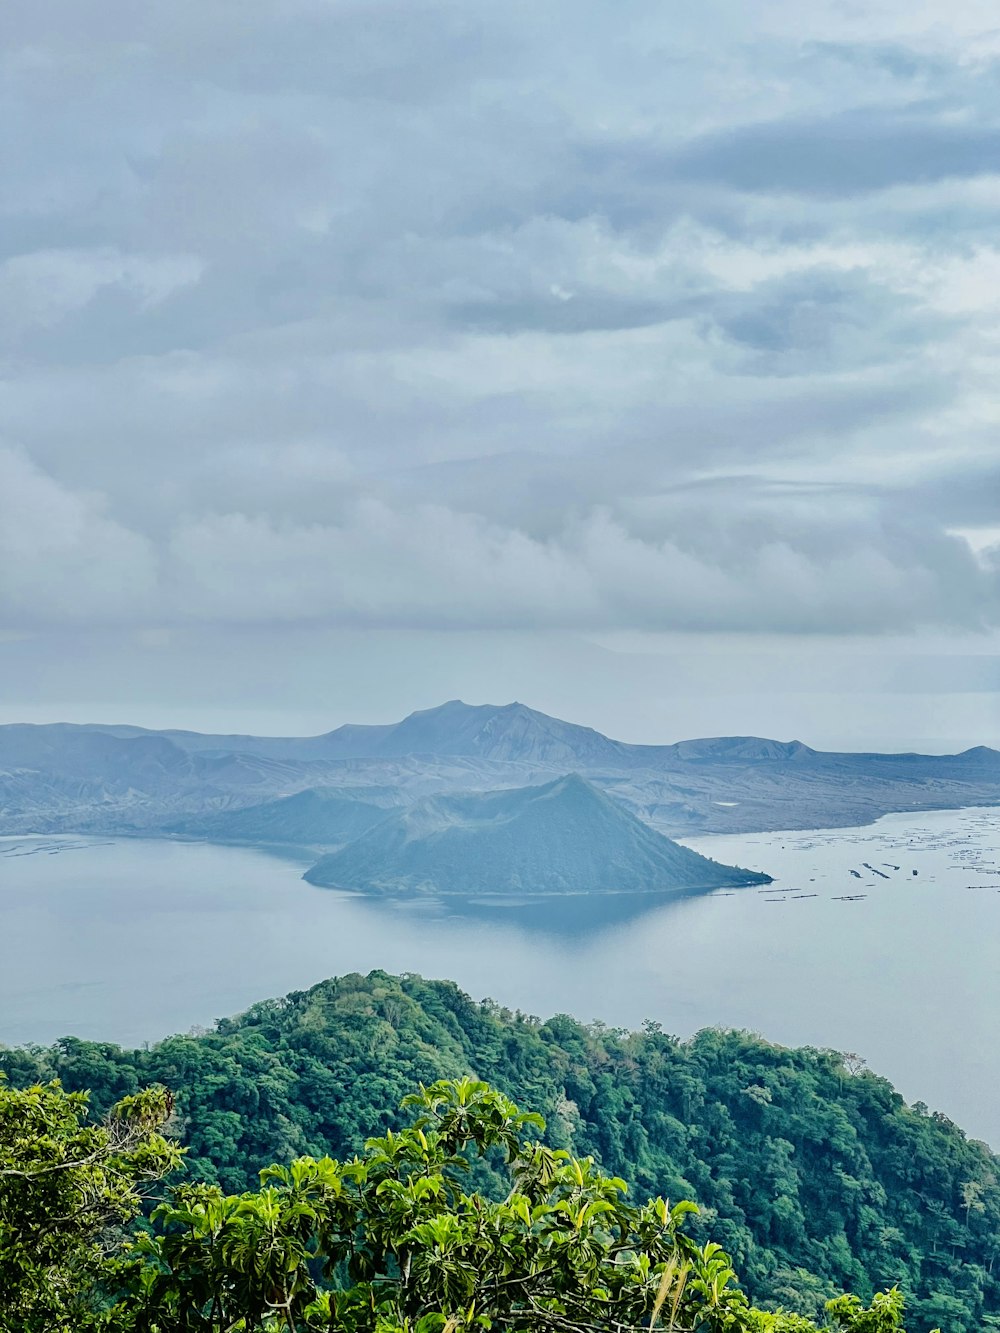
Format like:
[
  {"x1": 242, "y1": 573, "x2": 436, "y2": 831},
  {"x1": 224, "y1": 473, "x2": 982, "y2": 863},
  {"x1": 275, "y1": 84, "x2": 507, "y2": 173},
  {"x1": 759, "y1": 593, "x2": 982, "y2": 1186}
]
[{"x1": 0, "y1": 0, "x2": 1000, "y2": 749}]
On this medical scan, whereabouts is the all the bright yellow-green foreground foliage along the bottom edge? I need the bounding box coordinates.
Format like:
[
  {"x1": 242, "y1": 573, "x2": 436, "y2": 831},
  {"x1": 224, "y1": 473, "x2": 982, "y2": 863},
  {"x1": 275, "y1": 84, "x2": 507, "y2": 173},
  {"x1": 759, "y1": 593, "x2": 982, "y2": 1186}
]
[{"x1": 0, "y1": 1078, "x2": 922, "y2": 1333}]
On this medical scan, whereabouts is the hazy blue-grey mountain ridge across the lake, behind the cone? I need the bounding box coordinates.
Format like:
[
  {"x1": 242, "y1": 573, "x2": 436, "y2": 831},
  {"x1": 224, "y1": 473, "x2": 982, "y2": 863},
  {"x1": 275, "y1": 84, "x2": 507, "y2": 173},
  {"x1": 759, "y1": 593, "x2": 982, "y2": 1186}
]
[{"x1": 0, "y1": 701, "x2": 1000, "y2": 850}]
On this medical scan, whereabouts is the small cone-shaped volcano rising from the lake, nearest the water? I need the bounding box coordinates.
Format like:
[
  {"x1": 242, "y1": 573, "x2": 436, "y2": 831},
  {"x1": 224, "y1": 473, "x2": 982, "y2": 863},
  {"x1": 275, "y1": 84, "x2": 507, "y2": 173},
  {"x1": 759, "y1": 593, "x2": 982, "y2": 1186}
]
[{"x1": 305, "y1": 773, "x2": 771, "y2": 898}]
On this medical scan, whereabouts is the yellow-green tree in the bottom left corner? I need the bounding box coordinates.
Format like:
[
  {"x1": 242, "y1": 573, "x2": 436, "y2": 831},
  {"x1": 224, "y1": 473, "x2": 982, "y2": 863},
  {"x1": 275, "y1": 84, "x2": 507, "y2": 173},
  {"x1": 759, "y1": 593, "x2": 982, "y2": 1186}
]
[{"x1": 0, "y1": 1076, "x2": 181, "y2": 1333}]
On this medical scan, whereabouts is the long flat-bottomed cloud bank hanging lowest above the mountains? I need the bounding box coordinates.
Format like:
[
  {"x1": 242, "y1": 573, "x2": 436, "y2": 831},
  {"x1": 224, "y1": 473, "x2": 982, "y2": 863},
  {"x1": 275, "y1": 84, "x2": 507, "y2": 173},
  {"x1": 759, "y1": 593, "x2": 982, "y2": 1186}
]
[{"x1": 0, "y1": 451, "x2": 997, "y2": 633}]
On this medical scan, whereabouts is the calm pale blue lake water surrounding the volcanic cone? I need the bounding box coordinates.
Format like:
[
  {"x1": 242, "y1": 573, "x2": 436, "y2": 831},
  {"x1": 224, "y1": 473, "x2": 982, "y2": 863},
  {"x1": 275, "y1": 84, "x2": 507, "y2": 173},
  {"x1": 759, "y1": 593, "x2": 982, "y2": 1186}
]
[{"x1": 0, "y1": 809, "x2": 1000, "y2": 1146}]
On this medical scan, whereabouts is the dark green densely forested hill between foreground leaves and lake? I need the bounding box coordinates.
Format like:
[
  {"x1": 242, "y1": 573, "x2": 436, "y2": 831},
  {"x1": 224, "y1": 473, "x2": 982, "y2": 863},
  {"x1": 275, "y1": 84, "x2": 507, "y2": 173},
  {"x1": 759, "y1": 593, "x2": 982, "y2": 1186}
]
[{"x1": 0, "y1": 972, "x2": 1000, "y2": 1333}]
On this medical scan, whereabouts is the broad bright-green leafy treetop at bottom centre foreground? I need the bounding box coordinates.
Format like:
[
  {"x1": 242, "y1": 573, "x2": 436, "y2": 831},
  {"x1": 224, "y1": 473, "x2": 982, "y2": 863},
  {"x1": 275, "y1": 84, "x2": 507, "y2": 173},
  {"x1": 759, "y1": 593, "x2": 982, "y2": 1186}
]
[{"x1": 127, "y1": 1078, "x2": 917, "y2": 1333}]
